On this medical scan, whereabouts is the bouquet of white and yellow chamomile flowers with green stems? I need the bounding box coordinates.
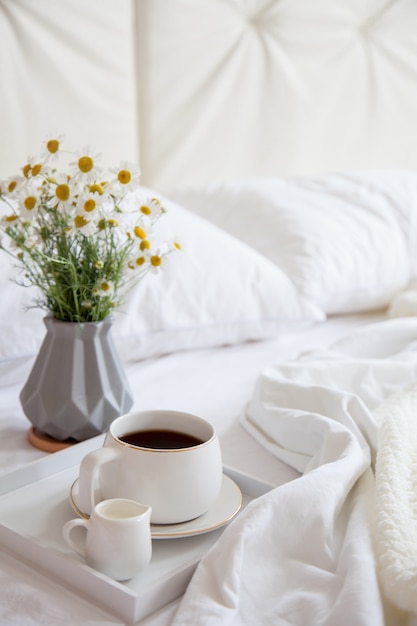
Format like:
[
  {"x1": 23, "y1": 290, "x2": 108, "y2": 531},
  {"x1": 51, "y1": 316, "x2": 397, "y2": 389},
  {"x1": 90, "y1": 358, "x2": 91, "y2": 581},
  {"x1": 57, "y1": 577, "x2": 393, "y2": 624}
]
[{"x1": 0, "y1": 136, "x2": 180, "y2": 322}]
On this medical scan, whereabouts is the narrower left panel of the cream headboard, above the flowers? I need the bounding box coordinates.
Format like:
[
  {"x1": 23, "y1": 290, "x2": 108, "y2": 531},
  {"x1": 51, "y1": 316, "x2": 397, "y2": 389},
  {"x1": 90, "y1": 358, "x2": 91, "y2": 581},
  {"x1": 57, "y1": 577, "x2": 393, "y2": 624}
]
[{"x1": 0, "y1": 0, "x2": 138, "y2": 178}]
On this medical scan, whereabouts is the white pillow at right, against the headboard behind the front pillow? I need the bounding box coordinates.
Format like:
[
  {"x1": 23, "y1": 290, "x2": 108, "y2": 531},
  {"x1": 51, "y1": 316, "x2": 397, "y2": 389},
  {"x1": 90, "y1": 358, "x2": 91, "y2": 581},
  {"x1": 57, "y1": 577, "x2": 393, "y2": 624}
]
[{"x1": 170, "y1": 171, "x2": 417, "y2": 314}]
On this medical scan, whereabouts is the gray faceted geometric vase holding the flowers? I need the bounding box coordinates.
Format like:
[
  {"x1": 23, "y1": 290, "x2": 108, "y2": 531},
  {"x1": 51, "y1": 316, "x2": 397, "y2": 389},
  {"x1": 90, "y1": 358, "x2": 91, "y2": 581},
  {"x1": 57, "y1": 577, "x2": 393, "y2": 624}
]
[{"x1": 20, "y1": 316, "x2": 133, "y2": 441}]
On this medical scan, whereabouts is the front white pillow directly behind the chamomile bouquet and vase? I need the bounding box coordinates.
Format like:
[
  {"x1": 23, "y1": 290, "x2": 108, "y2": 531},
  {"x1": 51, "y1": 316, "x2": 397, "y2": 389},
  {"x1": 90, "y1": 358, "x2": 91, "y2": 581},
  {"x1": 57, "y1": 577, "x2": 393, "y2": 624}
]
[{"x1": 0, "y1": 188, "x2": 324, "y2": 360}]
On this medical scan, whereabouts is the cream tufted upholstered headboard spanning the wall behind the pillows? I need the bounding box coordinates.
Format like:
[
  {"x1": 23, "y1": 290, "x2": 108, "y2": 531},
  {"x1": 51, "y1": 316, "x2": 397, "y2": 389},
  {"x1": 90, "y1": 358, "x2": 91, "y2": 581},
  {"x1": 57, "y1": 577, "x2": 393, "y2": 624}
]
[{"x1": 0, "y1": 0, "x2": 417, "y2": 190}]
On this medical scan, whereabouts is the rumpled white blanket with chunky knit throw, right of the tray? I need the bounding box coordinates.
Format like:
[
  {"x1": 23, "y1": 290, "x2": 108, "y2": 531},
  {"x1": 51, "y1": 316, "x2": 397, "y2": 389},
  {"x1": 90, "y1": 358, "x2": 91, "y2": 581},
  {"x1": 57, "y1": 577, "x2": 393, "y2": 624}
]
[{"x1": 174, "y1": 318, "x2": 417, "y2": 626}]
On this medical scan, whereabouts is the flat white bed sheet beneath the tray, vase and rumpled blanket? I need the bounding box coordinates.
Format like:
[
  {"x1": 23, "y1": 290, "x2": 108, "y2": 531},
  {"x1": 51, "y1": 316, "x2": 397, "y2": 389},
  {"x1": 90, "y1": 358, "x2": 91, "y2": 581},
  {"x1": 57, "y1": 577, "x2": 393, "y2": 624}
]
[{"x1": 0, "y1": 313, "x2": 384, "y2": 626}]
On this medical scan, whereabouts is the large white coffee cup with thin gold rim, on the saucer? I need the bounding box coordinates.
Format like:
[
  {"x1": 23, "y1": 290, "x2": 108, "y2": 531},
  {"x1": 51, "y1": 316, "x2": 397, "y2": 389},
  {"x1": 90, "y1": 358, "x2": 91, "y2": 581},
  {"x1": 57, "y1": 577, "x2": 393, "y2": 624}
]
[{"x1": 79, "y1": 410, "x2": 223, "y2": 524}]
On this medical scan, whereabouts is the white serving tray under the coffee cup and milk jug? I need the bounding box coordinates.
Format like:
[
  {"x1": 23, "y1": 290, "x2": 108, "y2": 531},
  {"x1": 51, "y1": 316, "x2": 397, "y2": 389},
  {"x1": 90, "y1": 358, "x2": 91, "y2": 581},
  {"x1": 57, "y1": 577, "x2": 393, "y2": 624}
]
[{"x1": 0, "y1": 435, "x2": 273, "y2": 623}]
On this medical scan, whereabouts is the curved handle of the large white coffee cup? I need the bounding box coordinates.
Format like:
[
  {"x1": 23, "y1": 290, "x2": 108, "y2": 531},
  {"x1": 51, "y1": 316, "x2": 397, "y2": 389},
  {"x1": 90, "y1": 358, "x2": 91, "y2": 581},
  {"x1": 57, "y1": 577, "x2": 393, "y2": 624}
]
[{"x1": 78, "y1": 446, "x2": 119, "y2": 515}]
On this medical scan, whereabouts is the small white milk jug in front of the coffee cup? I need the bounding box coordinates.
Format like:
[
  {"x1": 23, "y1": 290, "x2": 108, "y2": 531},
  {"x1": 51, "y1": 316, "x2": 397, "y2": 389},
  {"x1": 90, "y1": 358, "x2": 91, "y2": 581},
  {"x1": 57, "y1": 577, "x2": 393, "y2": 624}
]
[{"x1": 62, "y1": 498, "x2": 152, "y2": 581}]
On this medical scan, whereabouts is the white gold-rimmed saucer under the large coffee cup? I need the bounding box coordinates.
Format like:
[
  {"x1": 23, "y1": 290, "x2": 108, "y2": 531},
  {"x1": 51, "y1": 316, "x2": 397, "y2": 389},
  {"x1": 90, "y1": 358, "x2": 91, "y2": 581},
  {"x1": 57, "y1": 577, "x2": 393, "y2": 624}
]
[{"x1": 69, "y1": 474, "x2": 242, "y2": 539}]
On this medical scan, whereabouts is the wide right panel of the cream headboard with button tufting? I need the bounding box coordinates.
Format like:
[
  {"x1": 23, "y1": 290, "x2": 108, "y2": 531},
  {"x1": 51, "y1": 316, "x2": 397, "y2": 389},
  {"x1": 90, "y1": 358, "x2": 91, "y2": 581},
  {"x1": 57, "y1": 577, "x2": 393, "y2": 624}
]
[{"x1": 138, "y1": 0, "x2": 417, "y2": 187}]
